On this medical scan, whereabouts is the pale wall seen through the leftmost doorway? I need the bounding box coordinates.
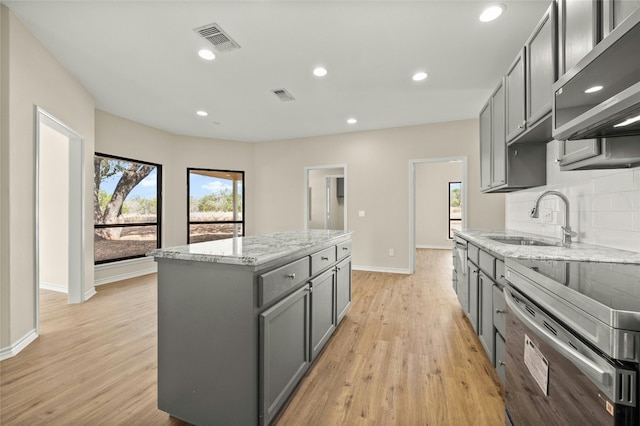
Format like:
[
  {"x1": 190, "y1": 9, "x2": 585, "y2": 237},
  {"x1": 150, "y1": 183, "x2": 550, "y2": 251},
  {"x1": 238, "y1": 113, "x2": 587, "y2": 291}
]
[{"x1": 38, "y1": 123, "x2": 70, "y2": 292}]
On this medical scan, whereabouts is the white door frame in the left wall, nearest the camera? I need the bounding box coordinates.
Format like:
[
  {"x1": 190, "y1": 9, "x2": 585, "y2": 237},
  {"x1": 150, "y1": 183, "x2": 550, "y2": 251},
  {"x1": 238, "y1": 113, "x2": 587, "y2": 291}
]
[{"x1": 34, "y1": 105, "x2": 86, "y2": 333}]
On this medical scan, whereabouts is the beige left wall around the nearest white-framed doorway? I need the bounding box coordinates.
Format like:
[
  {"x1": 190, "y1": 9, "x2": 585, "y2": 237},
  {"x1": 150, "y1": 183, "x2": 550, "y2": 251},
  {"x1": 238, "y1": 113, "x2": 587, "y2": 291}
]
[{"x1": 0, "y1": 6, "x2": 95, "y2": 350}]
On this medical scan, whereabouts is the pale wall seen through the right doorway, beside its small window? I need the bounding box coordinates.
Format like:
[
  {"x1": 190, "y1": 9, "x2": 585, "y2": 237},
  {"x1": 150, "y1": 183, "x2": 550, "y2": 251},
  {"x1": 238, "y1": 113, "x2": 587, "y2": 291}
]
[{"x1": 415, "y1": 162, "x2": 463, "y2": 248}]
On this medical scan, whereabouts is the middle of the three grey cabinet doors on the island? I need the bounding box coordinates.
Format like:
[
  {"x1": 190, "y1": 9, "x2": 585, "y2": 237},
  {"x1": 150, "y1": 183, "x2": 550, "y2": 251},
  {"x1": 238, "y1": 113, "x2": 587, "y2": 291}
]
[{"x1": 311, "y1": 270, "x2": 337, "y2": 362}]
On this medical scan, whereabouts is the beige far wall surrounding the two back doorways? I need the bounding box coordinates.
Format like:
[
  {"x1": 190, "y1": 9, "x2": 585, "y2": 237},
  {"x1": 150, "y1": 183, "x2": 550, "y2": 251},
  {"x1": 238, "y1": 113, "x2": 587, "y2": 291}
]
[{"x1": 255, "y1": 120, "x2": 505, "y2": 272}]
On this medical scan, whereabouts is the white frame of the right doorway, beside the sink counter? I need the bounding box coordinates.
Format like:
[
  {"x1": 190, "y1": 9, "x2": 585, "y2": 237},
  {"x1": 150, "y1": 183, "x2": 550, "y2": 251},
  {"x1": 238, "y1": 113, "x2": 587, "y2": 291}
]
[{"x1": 409, "y1": 155, "x2": 468, "y2": 274}]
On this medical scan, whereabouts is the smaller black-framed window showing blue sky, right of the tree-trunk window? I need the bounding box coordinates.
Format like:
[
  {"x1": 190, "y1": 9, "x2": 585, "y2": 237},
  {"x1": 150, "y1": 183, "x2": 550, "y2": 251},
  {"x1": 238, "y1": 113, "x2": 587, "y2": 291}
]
[{"x1": 187, "y1": 168, "x2": 244, "y2": 244}]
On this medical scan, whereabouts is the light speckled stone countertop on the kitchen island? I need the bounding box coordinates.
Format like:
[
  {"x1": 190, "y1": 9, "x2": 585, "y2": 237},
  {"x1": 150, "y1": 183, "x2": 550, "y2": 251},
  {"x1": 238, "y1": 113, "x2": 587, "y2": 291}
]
[{"x1": 147, "y1": 229, "x2": 351, "y2": 267}]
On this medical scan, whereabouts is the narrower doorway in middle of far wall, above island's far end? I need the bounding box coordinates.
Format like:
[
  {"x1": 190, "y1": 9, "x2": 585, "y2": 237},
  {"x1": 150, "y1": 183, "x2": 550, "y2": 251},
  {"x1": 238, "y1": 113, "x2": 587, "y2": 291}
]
[{"x1": 304, "y1": 165, "x2": 347, "y2": 230}]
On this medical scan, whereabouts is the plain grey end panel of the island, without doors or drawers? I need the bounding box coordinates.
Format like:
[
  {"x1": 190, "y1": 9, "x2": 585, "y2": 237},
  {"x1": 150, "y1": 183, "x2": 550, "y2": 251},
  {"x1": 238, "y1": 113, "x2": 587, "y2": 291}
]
[{"x1": 156, "y1": 259, "x2": 258, "y2": 425}]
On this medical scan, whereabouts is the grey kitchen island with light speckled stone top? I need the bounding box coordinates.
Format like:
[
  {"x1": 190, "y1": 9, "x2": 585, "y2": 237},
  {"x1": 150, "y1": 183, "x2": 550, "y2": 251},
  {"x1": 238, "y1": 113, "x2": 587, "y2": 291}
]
[{"x1": 149, "y1": 230, "x2": 351, "y2": 425}]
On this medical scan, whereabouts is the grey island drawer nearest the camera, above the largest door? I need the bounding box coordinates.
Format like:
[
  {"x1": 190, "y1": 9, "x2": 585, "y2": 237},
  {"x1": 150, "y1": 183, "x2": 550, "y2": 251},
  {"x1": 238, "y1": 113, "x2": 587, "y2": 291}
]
[{"x1": 258, "y1": 257, "x2": 310, "y2": 306}]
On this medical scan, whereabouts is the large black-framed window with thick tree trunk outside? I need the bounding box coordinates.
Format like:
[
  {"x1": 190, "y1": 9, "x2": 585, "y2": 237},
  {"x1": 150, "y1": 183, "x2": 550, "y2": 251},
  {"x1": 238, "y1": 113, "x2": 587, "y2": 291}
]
[{"x1": 93, "y1": 153, "x2": 162, "y2": 264}]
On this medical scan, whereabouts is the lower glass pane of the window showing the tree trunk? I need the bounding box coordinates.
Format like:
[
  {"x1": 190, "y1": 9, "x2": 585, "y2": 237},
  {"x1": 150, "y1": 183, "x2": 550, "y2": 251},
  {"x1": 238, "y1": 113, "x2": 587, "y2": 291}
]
[{"x1": 94, "y1": 225, "x2": 158, "y2": 263}]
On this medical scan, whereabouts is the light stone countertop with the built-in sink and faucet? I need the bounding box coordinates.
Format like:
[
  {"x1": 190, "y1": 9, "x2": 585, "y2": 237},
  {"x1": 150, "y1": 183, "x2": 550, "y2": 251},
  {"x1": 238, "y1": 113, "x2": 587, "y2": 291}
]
[{"x1": 454, "y1": 229, "x2": 640, "y2": 264}]
